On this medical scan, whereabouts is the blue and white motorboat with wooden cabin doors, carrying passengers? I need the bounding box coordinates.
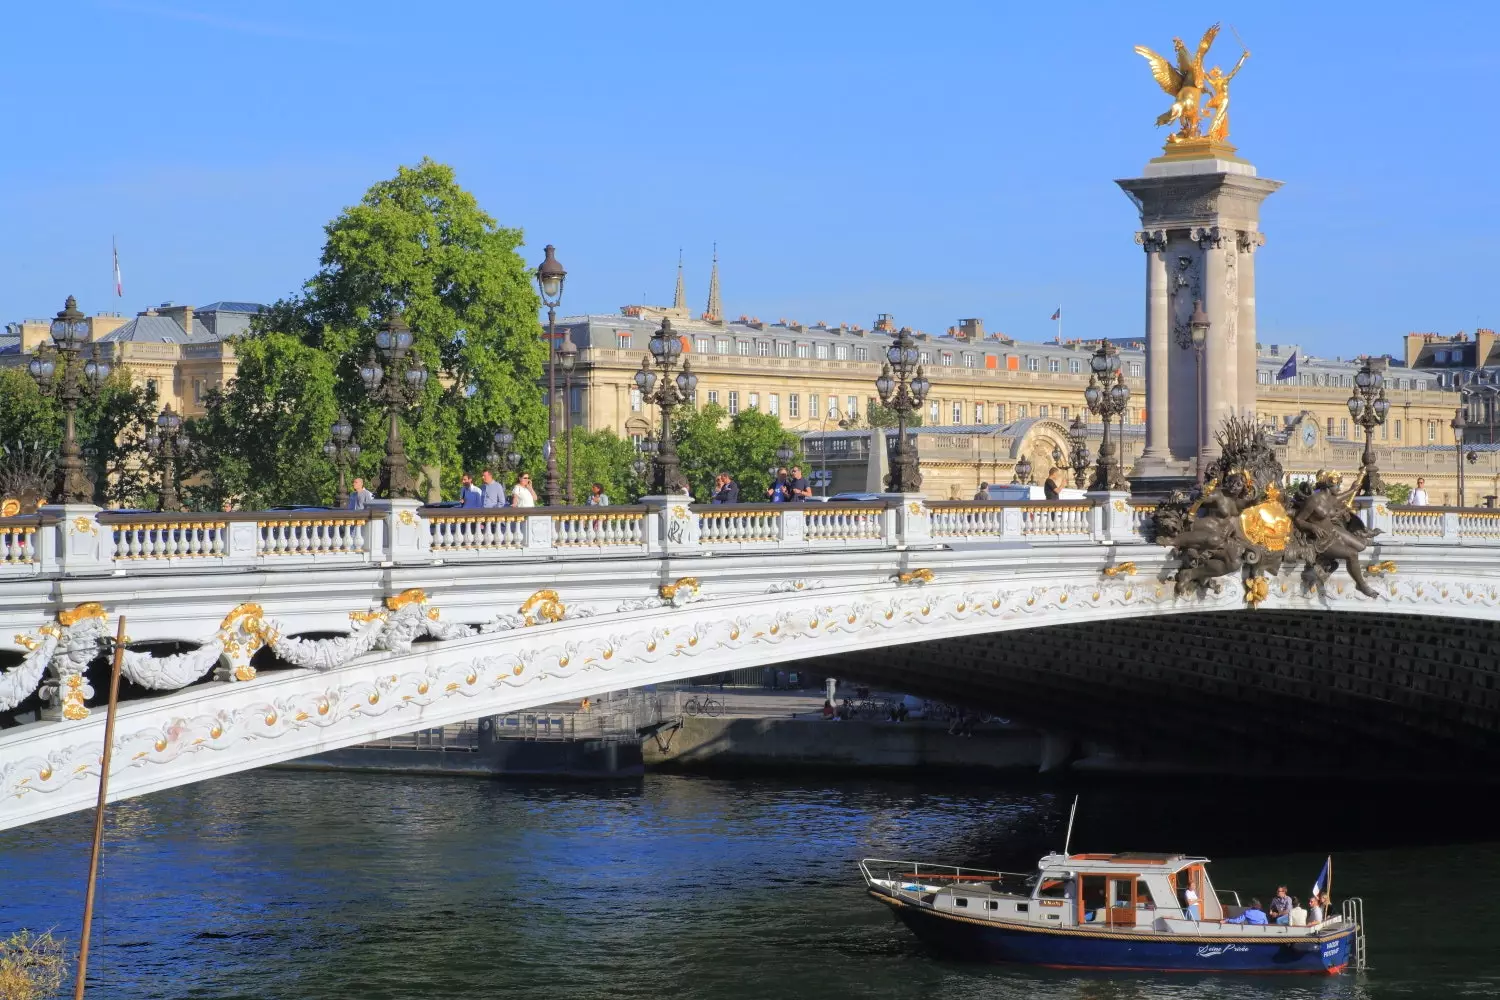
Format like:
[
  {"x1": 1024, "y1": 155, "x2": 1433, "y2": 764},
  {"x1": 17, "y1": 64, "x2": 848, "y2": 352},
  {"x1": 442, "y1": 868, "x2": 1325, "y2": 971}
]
[{"x1": 860, "y1": 852, "x2": 1365, "y2": 975}]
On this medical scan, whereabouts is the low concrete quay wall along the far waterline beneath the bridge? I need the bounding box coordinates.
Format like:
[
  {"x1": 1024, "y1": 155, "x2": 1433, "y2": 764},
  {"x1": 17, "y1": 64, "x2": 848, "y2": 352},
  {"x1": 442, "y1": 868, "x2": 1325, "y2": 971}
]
[{"x1": 641, "y1": 717, "x2": 1067, "y2": 771}]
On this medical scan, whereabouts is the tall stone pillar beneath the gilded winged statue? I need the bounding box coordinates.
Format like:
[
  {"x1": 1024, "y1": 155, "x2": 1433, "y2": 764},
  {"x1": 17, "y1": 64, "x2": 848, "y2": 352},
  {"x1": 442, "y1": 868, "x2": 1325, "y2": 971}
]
[{"x1": 1116, "y1": 154, "x2": 1281, "y2": 492}]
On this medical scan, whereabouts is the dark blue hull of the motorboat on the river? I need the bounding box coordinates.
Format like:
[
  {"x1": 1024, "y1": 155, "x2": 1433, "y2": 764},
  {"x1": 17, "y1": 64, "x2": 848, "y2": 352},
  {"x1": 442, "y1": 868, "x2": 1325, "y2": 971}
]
[{"x1": 872, "y1": 892, "x2": 1355, "y2": 975}]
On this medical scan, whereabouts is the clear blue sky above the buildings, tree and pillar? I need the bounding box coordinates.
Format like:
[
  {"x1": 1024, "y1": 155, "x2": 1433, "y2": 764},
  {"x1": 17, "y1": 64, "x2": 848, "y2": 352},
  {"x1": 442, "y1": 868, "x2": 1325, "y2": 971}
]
[{"x1": 0, "y1": 0, "x2": 1500, "y2": 355}]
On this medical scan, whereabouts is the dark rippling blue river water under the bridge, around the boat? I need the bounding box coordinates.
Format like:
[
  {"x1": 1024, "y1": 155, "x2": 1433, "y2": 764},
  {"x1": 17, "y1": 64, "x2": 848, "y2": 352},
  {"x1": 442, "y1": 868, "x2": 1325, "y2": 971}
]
[{"x1": 0, "y1": 771, "x2": 1500, "y2": 1000}]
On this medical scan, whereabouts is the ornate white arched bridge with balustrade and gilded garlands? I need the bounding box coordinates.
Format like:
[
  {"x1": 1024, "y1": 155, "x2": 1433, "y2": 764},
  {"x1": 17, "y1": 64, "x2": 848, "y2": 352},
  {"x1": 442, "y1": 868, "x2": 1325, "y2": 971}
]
[{"x1": 0, "y1": 493, "x2": 1500, "y2": 829}]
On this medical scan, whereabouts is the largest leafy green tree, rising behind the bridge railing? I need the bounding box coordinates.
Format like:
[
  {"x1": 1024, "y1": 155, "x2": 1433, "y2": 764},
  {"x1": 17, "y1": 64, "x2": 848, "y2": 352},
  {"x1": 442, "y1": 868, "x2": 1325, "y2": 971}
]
[{"x1": 196, "y1": 159, "x2": 546, "y2": 502}]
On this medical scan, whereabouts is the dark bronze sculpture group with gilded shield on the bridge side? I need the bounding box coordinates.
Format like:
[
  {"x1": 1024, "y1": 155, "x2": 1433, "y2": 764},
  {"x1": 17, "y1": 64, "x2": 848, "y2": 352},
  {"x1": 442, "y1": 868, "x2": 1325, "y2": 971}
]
[{"x1": 1151, "y1": 417, "x2": 1380, "y2": 606}]
